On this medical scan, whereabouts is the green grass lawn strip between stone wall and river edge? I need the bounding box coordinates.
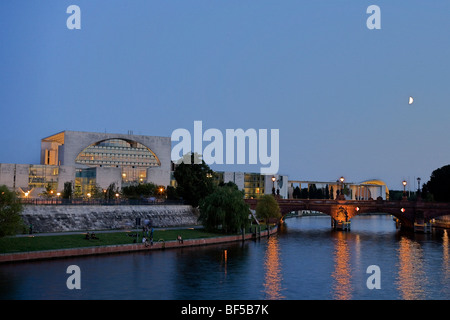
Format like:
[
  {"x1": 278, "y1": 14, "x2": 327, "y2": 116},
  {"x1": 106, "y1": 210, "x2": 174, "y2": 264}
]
[{"x1": 0, "y1": 229, "x2": 224, "y2": 253}]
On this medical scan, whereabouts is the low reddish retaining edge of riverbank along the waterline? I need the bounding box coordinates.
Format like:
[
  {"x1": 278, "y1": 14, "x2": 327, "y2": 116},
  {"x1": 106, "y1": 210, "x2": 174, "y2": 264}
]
[{"x1": 0, "y1": 226, "x2": 278, "y2": 263}]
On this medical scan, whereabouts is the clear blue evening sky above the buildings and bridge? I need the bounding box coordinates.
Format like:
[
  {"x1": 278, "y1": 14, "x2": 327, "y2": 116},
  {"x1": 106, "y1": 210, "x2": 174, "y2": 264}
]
[{"x1": 0, "y1": 0, "x2": 450, "y2": 189}]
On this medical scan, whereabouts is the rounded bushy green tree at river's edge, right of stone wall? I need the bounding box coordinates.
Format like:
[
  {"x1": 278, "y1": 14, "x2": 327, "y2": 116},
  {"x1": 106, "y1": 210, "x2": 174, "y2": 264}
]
[{"x1": 199, "y1": 184, "x2": 250, "y2": 233}]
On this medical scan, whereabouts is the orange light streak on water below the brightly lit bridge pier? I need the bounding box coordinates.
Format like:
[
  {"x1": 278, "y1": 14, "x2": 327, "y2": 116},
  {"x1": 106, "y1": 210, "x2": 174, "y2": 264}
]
[{"x1": 331, "y1": 232, "x2": 352, "y2": 300}]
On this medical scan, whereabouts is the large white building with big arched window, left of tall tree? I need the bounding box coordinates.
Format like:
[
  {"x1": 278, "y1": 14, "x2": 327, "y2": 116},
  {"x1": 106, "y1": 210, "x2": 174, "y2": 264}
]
[{"x1": 0, "y1": 131, "x2": 171, "y2": 197}]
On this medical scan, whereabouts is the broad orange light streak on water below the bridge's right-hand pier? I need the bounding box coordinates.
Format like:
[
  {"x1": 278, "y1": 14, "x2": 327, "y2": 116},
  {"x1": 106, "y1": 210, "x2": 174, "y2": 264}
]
[{"x1": 397, "y1": 237, "x2": 427, "y2": 300}]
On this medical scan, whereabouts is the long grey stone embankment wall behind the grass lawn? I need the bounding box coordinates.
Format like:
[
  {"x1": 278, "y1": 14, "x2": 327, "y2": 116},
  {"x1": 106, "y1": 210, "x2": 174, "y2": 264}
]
[{"x1": 22, "y1": 205, "x2": 198, "y2": 233}]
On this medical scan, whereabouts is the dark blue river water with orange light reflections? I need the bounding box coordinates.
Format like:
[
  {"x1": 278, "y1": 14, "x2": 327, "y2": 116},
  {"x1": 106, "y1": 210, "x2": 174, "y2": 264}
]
[{"x1": 0, "y1": 215, "x2": 450, "y2": 300}]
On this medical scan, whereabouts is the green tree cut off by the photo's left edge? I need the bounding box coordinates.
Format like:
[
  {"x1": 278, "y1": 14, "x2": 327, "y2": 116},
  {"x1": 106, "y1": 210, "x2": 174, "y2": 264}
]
[{"x1": 0, "y1": 185, "x2": 24, "y2": 237}]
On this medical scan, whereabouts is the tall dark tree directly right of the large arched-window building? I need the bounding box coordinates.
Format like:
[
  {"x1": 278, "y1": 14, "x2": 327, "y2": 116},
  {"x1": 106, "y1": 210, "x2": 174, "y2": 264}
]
[{"x1": 174, "y1": 154, "x2": 215, "y2": 207}]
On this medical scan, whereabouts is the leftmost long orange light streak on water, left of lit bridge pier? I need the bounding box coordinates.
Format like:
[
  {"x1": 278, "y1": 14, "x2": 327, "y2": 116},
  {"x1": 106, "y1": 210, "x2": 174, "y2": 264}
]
[{"x1": 264, "y1": 236, "x2": 284, "y2": 300}]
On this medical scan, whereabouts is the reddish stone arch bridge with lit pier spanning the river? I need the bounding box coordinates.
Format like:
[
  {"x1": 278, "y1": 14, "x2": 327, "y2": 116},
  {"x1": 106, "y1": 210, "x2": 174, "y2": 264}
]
[{"x1": 245, "y1": 197, "x2": 450, "y2": 232}]
